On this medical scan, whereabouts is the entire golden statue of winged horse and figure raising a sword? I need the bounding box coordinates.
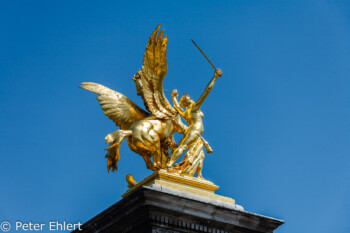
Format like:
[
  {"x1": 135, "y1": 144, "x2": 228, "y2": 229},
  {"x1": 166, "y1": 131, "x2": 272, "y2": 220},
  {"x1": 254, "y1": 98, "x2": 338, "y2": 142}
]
[{"x1": 80, "y1": 25, "x2": 222, "y2": 180}]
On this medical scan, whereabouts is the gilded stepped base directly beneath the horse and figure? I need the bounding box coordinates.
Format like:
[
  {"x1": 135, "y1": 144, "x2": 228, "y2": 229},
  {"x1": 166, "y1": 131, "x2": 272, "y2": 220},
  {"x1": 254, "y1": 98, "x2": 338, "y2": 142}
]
[{"x1": 122, "y1": 169, "x2": 235, "y2": 204}]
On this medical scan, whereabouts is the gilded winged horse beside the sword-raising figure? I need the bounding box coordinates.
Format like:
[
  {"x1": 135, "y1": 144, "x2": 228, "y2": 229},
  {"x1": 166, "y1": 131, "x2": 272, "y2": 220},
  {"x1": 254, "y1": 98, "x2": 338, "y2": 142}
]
[{"x1": 80, "y1": 25, "x2": 187, "y2": 171}]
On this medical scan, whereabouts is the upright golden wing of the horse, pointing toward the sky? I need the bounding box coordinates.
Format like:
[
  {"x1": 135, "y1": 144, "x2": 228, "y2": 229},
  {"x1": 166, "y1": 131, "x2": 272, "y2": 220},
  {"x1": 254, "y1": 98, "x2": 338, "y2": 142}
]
[{"x1": 133, "y1": 25, "x2": 177, "y2": 119}]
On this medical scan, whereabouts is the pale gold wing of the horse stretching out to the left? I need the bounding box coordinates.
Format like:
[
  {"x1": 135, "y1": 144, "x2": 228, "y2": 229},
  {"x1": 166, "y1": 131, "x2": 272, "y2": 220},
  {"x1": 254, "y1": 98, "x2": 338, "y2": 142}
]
[{"x1": 80, "y1": 82, "x2": 149, "y2": 129}]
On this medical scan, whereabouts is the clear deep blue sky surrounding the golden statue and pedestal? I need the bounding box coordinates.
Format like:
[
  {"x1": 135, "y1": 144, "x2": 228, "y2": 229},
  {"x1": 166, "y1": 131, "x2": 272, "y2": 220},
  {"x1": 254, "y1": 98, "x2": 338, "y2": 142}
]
[{"x1": 0, "y1": 0, "x2": 350, "y2": 233}]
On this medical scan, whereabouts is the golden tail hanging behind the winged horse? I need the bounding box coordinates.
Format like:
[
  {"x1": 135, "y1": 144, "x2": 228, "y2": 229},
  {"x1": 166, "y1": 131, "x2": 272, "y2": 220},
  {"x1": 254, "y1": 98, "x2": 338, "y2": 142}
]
[{"x1": 105, "y1": 130, "x2": 132, "y2": 172}]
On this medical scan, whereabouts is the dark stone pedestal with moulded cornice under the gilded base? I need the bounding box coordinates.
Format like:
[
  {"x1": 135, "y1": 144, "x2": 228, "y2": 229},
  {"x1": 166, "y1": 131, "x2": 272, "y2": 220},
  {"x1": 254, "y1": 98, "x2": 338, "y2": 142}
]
[{"x1": 74, "y1": 185, "x2": 283, "y2": 233}]
